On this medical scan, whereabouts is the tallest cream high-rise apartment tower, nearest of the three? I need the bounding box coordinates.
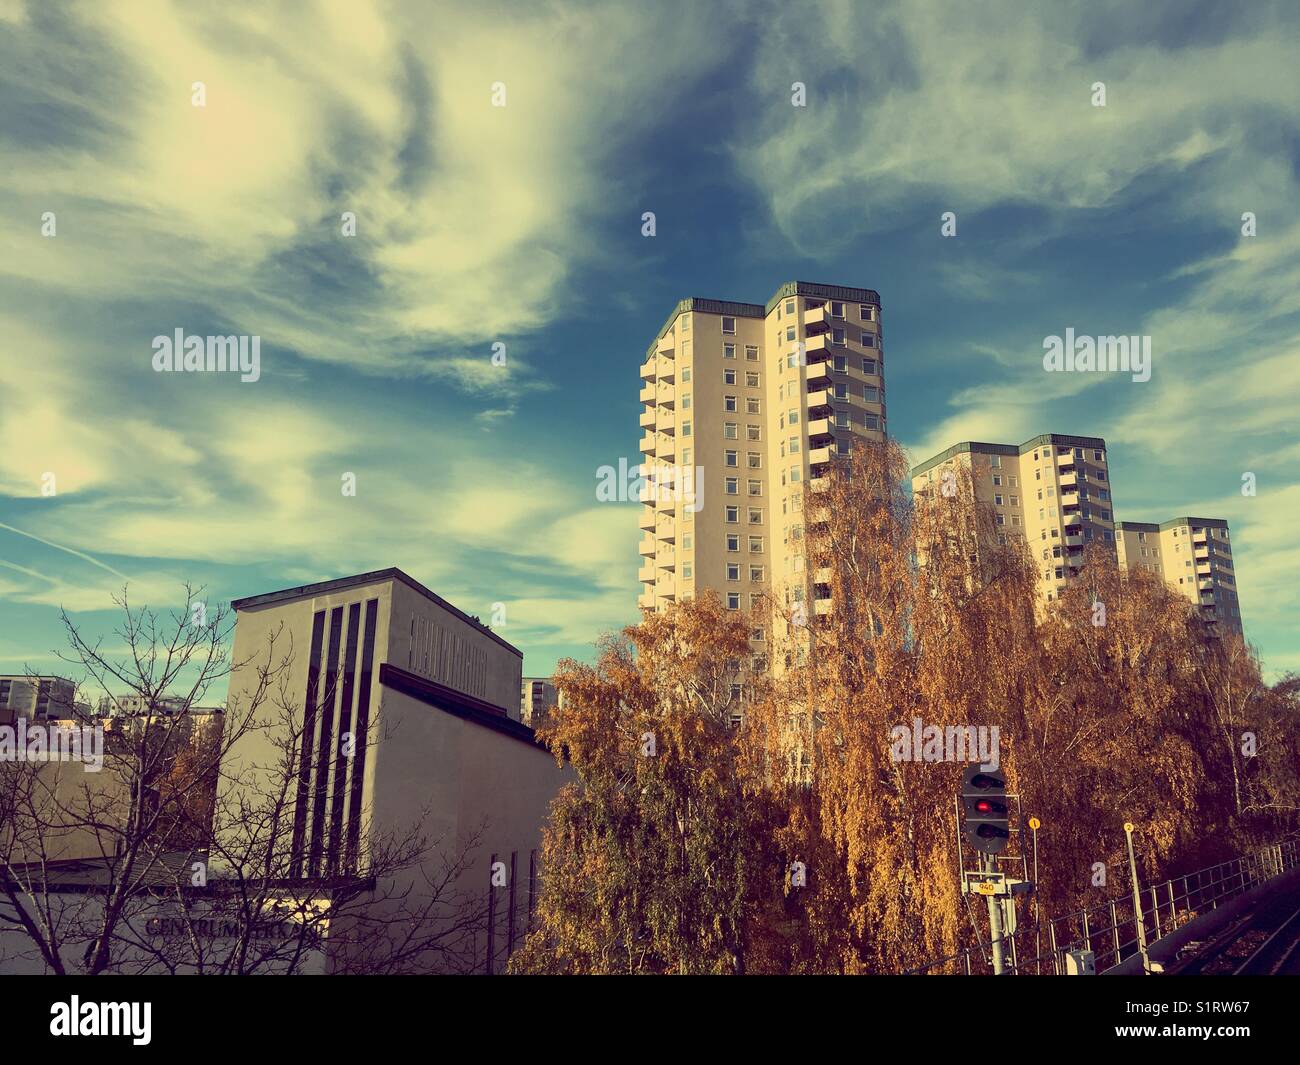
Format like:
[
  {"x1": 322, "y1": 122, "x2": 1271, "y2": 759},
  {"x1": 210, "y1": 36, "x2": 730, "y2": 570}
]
[{"x1": 637, "y1": 281, "x2": 885, "y2": 644}]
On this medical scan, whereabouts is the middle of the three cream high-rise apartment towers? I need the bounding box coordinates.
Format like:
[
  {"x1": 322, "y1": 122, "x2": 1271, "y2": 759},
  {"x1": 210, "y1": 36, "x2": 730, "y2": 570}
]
[{"x1": 911, "y1": 433, "x2": 1115, "y2": 601}]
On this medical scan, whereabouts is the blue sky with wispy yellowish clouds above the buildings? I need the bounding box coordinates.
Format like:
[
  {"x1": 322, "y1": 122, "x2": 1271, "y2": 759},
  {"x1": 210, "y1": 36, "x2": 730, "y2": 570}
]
[{"x1": 0, "y1": 0, "x2": 1300, "y2": 696}]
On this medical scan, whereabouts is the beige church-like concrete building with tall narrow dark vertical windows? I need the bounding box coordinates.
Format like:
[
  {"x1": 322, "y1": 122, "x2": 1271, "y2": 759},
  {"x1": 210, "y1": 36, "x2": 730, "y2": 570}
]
[{"x1": 218, "y1": 568, "x2": 569, "y2": 971}]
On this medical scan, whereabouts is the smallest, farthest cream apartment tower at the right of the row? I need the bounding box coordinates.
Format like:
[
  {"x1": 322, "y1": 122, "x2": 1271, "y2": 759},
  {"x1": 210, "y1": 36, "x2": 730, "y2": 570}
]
[{"x1": 1117, "y1": 518, "x2": 1242, "y2": 636}]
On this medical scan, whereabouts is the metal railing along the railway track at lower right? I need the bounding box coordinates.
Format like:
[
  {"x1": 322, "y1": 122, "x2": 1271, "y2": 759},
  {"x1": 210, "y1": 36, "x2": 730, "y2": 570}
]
[{"x1": 907, "y1": 839, "x2": 1300, "y2": 977}]
